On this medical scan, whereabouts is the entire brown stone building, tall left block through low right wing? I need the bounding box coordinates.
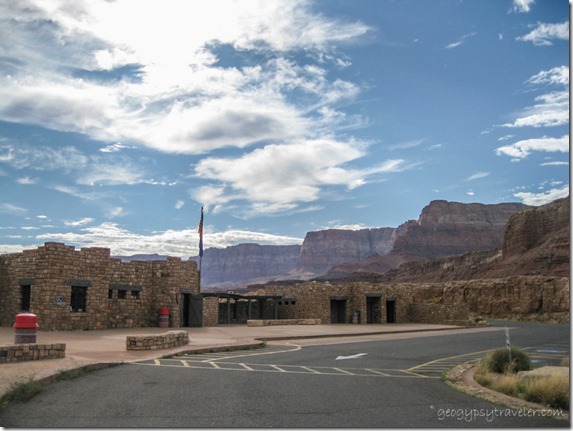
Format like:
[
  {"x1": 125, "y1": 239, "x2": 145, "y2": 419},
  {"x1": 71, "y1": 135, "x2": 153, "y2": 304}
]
[{"x1": 0, "y1": 242, "x2": 469, "y2": 331}]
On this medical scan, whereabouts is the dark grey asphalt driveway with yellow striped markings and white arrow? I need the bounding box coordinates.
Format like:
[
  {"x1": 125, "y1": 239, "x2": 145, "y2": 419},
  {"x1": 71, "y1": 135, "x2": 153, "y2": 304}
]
[{"x1": 0, "y1": 324, "x2": 569, "y2": 428}]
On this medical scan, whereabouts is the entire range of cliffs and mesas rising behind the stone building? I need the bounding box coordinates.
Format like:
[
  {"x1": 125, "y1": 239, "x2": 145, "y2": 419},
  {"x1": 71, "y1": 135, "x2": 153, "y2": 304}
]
[{"x1": 189, "y1": 200, "x2": 569, "y2": 289}]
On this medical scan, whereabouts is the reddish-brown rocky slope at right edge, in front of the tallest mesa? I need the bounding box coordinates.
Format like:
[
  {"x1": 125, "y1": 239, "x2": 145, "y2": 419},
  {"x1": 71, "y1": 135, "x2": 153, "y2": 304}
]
[{"x1": 344, "y1": 197, "x2": 570, "y2": 282}]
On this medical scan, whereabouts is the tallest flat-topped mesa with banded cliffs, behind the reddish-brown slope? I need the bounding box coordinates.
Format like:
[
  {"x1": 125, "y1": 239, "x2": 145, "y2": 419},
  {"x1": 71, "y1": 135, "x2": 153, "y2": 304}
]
[{"x1": 326, "y1": 200, "x2": 531, "y2": 278}]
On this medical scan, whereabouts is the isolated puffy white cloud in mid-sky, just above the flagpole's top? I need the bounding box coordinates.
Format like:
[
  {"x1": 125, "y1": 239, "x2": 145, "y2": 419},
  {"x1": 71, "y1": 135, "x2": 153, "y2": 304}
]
[{"x1": 192, "y1": 139, "x2": 405, "y2": 214}]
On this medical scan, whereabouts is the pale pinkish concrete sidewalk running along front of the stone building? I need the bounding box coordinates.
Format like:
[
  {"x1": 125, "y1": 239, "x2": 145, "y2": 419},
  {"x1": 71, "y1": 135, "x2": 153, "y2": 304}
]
[{"x1": 0, "y1": 323, "x2": 460, "y2": 397}]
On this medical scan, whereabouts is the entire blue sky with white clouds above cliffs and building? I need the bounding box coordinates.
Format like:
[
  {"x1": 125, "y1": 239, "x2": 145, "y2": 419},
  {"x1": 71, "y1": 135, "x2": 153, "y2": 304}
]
[{"x1": 0, "y1": 0, "x2": 569, "y2": 258}]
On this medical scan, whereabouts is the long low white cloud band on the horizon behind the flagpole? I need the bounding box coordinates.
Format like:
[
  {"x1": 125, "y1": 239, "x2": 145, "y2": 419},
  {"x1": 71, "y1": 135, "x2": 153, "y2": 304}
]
[{"x1": 34, "y1": 222, "x2": 302, "y2": 258}]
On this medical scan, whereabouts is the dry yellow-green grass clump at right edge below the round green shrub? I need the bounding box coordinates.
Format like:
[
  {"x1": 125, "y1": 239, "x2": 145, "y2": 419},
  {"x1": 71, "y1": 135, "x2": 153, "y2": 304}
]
[{"x1": 523, "y1": 375, "x2": 569, "y2": 410}]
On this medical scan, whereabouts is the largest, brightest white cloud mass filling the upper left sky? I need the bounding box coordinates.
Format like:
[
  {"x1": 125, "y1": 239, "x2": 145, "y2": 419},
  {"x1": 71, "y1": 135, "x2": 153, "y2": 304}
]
[{"x1": 0, "y1": 0, "x2": 370, "y2": 154}]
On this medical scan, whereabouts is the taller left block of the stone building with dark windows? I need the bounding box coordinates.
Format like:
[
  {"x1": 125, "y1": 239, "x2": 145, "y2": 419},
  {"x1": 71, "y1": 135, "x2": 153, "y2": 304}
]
[{"x1": 0, "y1": 242, "x2": 199, "y2": 330}]
